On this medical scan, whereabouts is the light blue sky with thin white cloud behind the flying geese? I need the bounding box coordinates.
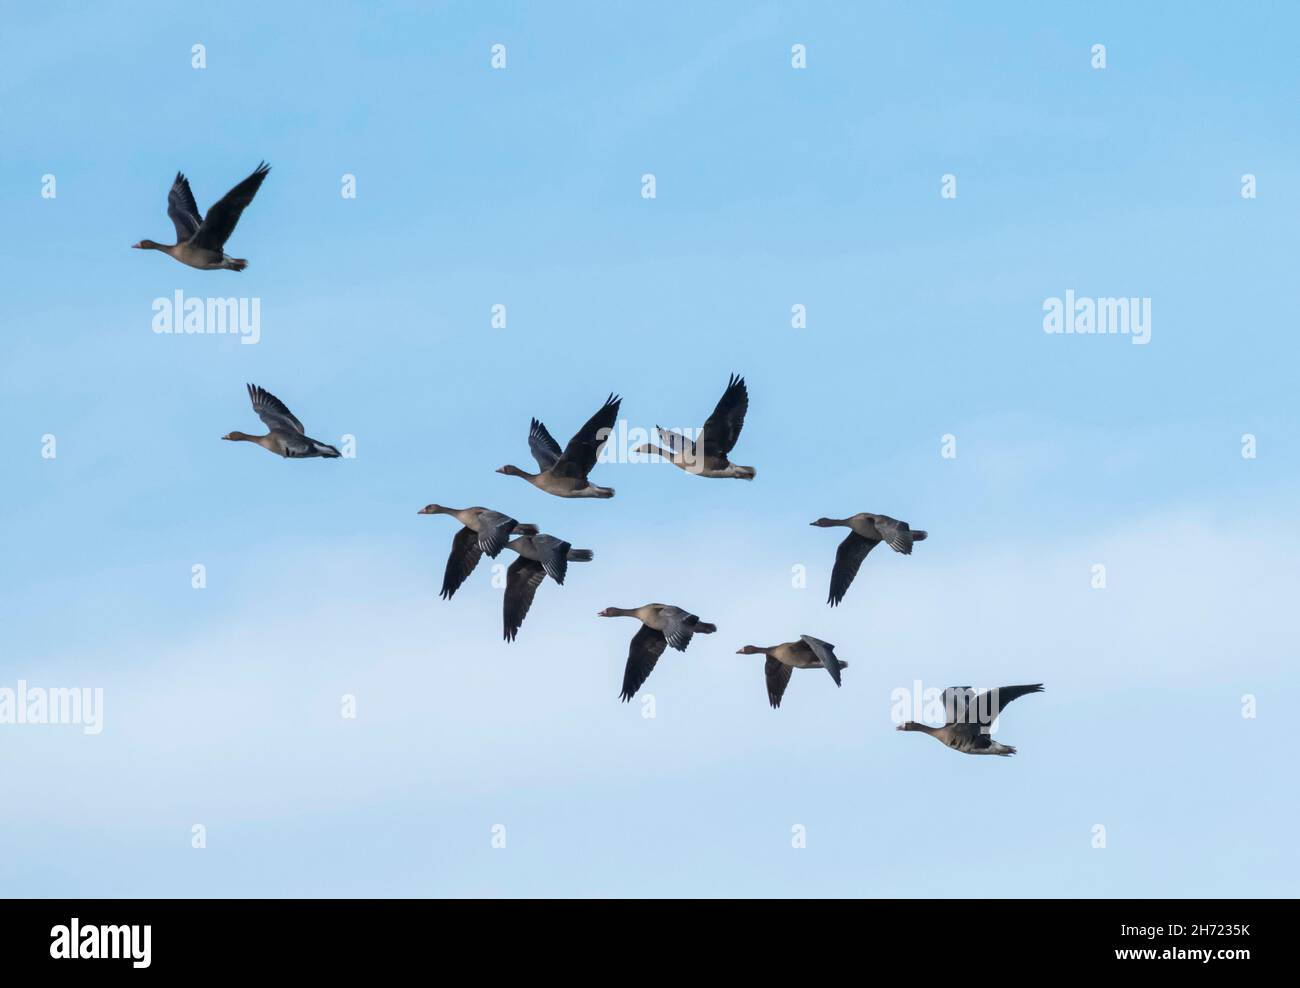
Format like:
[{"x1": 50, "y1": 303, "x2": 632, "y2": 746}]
[{"x1": 0, "y1": 3, "x2": 1300, "y2": 897}]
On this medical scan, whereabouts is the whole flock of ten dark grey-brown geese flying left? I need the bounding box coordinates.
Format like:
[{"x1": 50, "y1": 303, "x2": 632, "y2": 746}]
[{"x1": 133, "y1": 163, "x2": 1043, "y2": 755}]
